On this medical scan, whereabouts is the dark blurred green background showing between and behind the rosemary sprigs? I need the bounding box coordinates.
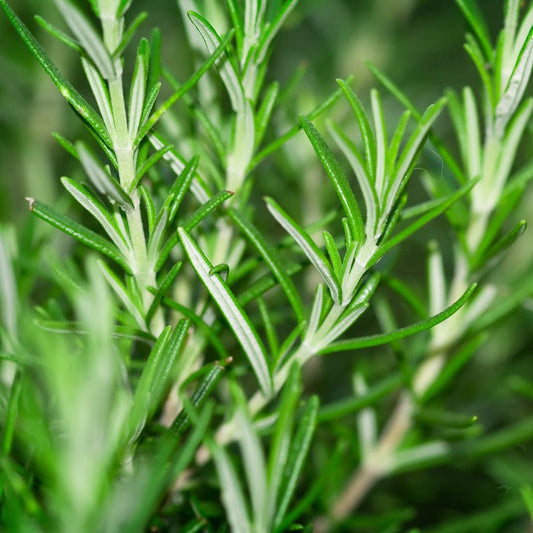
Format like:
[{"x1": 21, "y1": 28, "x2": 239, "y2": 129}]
[{"x1": 0, "y1": 0, "x2": 533, "y2": 533}]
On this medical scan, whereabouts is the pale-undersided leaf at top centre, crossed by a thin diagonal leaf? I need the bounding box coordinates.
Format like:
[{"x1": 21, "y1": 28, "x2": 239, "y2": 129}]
[{"x1": 187, "y1": 11, "x2": 245, "y2": 113}]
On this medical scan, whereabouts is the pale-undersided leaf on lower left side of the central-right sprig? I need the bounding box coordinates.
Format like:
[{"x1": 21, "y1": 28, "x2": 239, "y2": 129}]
[{"x1": 265, "y1": 198, "x2": 341, "y2": 303}]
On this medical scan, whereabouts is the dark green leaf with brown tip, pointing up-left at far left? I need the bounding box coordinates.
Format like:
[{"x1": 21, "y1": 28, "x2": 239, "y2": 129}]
[{"x1": 27, "y1": 198, "x2": 131, "y2": 272}]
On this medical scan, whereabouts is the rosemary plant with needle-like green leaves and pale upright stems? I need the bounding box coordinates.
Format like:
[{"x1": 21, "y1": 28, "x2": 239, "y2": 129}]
[{"x1": 0, "y1": 0, "x2": 533, "y2": 533}]
